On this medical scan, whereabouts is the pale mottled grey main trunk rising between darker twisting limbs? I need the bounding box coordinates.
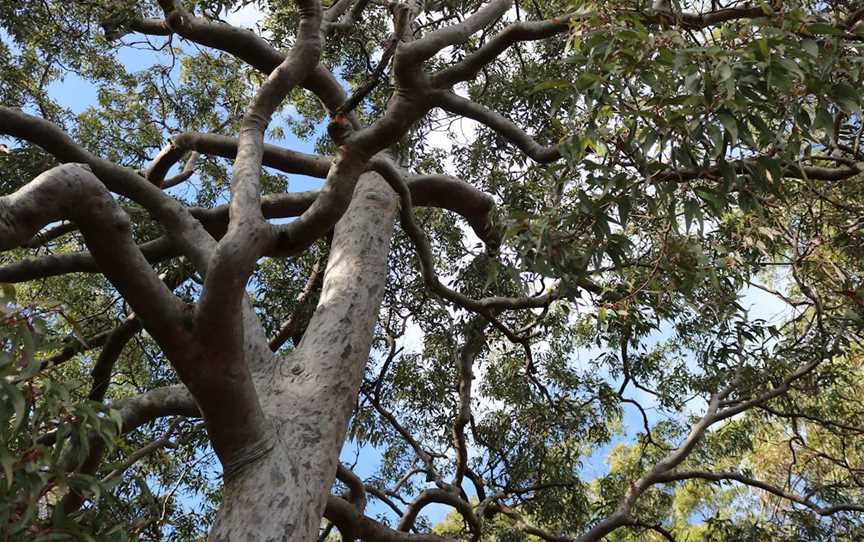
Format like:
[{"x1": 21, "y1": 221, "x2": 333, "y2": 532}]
[{"x1": 210, "y1": 173, "x2": 397, "y2": 542}]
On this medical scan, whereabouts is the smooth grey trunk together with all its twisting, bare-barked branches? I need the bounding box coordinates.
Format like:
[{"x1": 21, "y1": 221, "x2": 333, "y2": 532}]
[{"x1": 0, "y1": 0, "x2": 860, "y2": 541}]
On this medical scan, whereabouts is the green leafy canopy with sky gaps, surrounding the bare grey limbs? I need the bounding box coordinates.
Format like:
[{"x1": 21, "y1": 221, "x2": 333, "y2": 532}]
[{"x1": 0, "y1": 0, "x2": 864, "y2": 542}]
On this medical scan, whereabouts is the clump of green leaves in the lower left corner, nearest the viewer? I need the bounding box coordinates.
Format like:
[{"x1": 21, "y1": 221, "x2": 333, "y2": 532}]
[{"x1": 0, "y1": 284, "x2": 127, "y2": 541}]
